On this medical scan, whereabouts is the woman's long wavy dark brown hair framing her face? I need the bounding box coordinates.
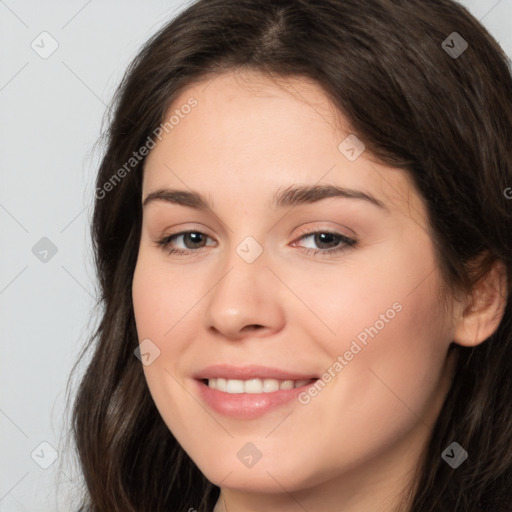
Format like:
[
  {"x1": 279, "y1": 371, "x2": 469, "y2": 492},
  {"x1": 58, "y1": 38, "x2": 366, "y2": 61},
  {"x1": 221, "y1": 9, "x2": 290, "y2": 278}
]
[{"x1": 65, "y1": 0, "x2": 512, "y2": 512}]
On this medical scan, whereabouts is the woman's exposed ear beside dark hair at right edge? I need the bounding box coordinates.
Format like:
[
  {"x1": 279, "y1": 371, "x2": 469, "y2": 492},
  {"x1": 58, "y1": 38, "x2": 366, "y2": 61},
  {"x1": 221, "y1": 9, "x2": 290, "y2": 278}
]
[{"x1": 453, "y1": 260, "x2": 508, "y2": 347}]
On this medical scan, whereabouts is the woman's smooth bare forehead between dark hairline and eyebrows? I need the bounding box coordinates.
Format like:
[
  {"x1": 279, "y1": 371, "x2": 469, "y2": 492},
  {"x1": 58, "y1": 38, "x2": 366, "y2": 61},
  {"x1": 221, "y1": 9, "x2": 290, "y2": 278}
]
[{"x1": 144, "y1": 72, "x2": 424, "y2": 225}]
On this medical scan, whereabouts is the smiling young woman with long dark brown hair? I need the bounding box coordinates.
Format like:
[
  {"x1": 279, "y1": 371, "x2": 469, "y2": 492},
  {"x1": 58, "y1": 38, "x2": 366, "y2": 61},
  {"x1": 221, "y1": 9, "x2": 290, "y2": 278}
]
[{"x1": 73, "y1": 0, "x2": 512, "y2": 512}]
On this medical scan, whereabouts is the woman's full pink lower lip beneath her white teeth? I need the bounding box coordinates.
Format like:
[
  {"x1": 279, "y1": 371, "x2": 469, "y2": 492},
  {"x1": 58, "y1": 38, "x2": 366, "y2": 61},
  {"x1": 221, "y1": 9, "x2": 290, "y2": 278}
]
[{"x1": 196, "y1": 380, "x2": 314, "y2": 420}]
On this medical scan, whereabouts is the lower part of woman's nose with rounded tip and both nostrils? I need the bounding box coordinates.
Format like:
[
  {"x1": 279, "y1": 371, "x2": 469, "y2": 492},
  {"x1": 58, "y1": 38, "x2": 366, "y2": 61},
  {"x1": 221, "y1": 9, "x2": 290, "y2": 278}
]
[{"x1": 204, "y1": 248, "x2": 285, "y2": 340}]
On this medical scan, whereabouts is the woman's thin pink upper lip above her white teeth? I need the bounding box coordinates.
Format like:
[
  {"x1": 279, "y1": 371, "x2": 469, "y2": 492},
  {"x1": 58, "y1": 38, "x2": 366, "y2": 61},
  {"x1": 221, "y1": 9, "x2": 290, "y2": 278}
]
[{"x1": 194, "y1": 364, "x2": 317, "y2": 380}]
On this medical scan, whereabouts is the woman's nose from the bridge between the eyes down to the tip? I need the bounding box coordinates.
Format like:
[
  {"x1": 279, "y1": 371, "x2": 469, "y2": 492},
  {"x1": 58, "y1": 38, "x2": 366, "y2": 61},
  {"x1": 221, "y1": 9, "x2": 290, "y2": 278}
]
[{"x1": 205, "y1": 236, "x2": 284, "y2": 338}]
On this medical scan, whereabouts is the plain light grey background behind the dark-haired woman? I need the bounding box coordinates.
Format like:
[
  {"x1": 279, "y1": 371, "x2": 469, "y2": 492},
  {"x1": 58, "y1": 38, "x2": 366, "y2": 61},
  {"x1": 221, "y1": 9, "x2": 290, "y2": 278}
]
[{"x1": 0, "y1": 0, "x2": 512, "y2": 512}]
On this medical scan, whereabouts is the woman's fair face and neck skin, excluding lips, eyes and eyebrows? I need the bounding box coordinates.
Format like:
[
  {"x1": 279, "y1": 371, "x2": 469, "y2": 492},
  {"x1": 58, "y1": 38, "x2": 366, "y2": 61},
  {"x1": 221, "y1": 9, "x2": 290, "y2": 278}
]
[{"x1": 132, "y1": 72, "x2": 506, "y2": 512}]
